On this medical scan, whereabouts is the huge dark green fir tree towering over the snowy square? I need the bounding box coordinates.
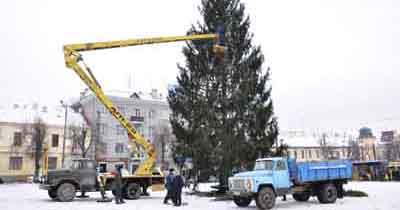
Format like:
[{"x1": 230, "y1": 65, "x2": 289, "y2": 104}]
[{"x1": 168, "y1": 0, "x2": 278, "y2": 186}]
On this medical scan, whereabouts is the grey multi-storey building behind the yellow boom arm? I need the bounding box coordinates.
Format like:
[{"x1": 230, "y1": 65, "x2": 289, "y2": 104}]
[{"x1": 80, "y1": 90, "x2": 173, "y2": 172}]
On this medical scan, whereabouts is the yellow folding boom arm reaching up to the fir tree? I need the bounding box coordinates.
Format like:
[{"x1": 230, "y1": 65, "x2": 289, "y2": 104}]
[{"x1": 64, "y1": 34, "x2": 224, "y2": 176}]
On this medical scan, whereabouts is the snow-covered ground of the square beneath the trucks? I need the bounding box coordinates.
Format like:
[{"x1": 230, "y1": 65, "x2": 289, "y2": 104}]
[{"x1": 0, "y1": 182, "x2": 400, "y2": 210}]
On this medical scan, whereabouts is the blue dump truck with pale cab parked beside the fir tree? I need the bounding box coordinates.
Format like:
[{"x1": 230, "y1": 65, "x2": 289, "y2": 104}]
[{"x1": 229, "y1": 157, "x2": 352, "y2": 210}]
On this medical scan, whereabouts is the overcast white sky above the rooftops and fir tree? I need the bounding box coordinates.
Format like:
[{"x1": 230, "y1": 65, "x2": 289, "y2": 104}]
[{"x1": 0, "y1": 0, "x2": 400, "y2": 133}]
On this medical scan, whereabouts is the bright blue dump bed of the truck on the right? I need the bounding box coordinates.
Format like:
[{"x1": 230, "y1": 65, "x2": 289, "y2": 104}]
[{"x1": 289, "y1": 160, "x2": 352, "y2": 183}]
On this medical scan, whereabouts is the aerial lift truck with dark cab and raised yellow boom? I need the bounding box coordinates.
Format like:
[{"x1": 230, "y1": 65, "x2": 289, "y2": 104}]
[{"x1": 40, "y1": 27, "x2": 225, "y2": 201}]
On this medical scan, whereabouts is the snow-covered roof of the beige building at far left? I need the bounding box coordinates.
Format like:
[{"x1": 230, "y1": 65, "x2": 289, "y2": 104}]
[{"x1": 0, "y1": 103, "x2": 84, "y2": 126}]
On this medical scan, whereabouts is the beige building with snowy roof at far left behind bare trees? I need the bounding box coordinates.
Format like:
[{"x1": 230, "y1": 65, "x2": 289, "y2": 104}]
[{"x1": 0, "y1": 104, "x2": 83, "y2": 182}]
